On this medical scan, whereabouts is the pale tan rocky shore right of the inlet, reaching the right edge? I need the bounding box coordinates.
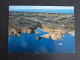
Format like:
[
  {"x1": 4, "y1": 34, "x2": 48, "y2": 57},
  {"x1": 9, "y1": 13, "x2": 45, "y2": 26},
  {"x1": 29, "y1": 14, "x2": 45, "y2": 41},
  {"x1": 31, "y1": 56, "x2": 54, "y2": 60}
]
[{"x1": 36, "y1": 28, "x2": 75, "y2": 40}]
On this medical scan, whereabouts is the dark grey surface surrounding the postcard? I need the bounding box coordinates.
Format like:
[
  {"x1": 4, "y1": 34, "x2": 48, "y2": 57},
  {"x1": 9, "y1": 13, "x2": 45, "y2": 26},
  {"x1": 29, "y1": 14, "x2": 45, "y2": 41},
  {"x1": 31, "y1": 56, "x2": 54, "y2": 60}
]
[{"x1": 0, "y1": 0, "x2": 80, "y2": 60}]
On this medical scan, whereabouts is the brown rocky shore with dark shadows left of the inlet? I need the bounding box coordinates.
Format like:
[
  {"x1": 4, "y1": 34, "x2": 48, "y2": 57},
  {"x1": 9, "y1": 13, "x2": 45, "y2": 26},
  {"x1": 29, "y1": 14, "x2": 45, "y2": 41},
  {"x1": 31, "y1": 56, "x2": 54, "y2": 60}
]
[{"x1": 8, "y1": 28, "x2": 41, "y2": 36}]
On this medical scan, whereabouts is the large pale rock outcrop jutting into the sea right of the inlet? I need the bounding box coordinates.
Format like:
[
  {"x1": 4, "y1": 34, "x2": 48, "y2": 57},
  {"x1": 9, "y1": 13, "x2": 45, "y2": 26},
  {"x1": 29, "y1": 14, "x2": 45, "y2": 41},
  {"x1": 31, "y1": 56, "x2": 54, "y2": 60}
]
[{"x1": 35, "y1": 30, "x2": 68, "y2": 40}]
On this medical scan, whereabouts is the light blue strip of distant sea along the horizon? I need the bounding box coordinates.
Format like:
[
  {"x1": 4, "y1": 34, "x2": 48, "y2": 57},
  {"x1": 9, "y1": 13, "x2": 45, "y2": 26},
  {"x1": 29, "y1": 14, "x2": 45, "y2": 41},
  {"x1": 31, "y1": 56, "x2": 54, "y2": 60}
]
[{"x1": 9, "y1": 9, "x2": 74, "y2": 14}]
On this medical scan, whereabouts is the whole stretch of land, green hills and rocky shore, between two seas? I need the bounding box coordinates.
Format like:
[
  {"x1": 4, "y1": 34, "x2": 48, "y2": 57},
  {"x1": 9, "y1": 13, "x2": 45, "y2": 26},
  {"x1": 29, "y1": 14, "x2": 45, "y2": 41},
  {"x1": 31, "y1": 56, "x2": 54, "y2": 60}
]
[{"x1": 8, "y1": 12, "x2": 75, "y2": 40}]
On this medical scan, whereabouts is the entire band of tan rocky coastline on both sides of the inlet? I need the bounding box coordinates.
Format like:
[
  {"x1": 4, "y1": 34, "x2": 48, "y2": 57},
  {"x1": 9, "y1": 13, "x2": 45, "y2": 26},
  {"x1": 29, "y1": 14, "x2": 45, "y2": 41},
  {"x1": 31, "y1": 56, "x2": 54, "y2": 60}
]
[{"x1": 8, "y1": 28, "x2": 75, "y2": 40}]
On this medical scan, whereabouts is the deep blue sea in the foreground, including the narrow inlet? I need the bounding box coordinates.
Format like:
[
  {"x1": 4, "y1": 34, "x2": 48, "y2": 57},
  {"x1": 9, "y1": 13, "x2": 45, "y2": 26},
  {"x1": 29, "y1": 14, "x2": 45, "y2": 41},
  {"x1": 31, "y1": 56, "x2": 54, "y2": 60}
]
[{"x1": 8, "y1": 28, "x2": 75, "y2": 53}]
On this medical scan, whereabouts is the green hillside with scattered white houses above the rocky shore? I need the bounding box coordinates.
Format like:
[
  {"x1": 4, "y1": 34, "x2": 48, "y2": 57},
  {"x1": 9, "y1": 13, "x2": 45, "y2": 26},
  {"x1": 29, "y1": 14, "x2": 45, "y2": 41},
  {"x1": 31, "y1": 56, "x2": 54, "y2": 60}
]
[{"x1": 8, "y1": 12, "x2": 74, "y2": 36}]
